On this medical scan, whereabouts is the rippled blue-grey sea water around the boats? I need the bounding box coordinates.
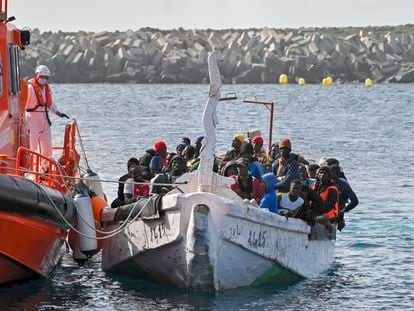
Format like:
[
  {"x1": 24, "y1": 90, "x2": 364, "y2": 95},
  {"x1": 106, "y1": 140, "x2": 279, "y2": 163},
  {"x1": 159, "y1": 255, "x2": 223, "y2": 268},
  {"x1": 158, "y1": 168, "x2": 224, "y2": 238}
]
[{"x1": 0, "y1": 84, "x2": 414, "y2": 310}]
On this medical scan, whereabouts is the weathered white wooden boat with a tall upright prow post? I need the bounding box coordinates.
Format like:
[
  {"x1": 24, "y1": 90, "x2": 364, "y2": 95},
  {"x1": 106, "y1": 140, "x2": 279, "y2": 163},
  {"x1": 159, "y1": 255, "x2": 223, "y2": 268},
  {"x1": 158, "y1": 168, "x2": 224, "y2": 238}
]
[{"x1": 102, "y1": 49, "x2": 336, "y2": 291}]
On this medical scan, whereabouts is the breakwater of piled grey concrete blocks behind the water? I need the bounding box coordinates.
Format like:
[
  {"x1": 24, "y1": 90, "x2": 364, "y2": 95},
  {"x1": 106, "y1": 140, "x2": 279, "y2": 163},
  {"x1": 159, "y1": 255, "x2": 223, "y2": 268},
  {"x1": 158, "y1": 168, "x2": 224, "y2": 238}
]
[{"x1": 21, "y1": 25, "x2": 414, "y2": 84}]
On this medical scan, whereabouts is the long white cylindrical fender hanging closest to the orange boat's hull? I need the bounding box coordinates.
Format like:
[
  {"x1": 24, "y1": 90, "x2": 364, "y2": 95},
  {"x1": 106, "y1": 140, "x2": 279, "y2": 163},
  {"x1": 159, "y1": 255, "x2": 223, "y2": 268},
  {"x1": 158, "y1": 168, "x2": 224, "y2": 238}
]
[{"x1": 74, "y1": 193, "x2": 98, "y2": 256}]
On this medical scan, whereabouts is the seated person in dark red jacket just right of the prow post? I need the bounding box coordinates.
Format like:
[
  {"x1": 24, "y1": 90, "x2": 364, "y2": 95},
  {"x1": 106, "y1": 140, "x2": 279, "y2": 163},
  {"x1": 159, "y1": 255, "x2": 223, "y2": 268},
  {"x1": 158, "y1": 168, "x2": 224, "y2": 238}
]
[{"x1": 230, "y1": 158, "x2": 264, "y2": 202}]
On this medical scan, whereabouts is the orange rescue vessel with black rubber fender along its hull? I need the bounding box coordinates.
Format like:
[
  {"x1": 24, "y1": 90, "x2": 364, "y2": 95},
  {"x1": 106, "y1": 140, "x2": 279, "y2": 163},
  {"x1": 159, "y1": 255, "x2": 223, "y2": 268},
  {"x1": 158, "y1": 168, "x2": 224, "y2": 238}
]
[{"x1": 0, "y1": 0, "x2": 103, "y2": 285}]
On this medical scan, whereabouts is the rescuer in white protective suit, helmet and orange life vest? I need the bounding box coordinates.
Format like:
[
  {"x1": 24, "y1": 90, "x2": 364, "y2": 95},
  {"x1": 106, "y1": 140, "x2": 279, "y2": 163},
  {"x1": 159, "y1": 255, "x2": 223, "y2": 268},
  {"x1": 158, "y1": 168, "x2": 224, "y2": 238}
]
[{"x1": 26, "y1": 65, "x2": 69, "y2": 158}]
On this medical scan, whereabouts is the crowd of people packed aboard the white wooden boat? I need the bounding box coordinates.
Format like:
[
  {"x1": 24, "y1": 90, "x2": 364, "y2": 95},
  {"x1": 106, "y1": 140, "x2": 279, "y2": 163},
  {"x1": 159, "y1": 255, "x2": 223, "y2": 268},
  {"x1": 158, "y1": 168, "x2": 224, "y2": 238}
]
[{"x1": 112, "y1": 134, "x2": 358, "y2": 230}]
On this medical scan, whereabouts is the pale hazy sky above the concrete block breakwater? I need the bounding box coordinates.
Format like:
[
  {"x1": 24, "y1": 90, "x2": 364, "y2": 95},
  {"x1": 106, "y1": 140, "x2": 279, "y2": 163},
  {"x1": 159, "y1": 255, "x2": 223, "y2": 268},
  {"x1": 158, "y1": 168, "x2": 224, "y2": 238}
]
[{"x1": 9, "y1": 0, "x2": 414, "y2": 31}]
